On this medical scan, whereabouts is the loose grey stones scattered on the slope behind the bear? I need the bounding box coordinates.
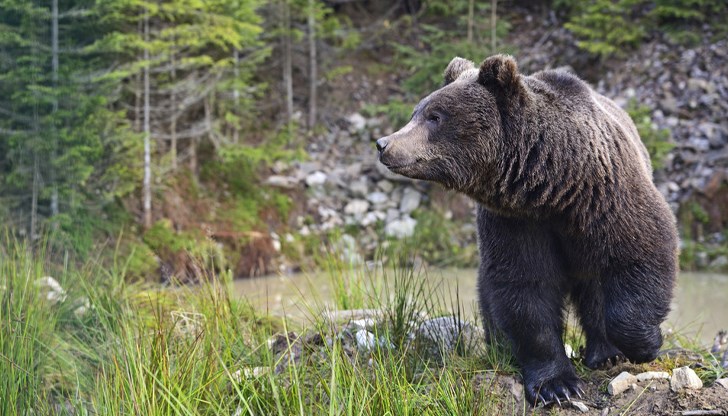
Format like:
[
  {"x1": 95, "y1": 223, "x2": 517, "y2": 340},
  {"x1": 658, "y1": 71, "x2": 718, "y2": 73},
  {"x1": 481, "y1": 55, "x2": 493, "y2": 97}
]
[{"x1": 266, "y1": 15, "x2": 728, "y2": 268}]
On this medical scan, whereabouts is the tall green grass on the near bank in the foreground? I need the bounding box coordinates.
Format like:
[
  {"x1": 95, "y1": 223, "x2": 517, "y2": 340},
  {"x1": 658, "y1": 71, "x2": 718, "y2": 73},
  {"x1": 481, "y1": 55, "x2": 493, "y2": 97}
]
[{"x1": 0, "y1": 244, "x2": 723, "y2": 415}]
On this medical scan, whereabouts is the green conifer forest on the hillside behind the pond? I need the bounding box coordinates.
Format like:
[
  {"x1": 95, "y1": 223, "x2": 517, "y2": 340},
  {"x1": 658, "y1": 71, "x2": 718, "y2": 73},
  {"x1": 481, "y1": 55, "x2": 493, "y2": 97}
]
[{"x1": 0, "y1": 0, "x2": 728, "y2": 280}]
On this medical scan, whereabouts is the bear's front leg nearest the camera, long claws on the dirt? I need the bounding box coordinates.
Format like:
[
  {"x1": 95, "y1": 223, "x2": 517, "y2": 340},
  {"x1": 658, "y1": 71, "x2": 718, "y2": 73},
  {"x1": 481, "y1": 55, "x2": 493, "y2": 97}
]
[{"x1": 478, "y1": 207, "x2": 582, "y2": 404}]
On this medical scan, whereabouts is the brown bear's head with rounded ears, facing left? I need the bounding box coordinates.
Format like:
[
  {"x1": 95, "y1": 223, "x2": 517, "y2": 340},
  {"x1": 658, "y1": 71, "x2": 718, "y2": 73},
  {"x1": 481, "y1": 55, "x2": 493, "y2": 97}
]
[{"x1": 377, "y1": 55, "x2": 524, "y2": 195}]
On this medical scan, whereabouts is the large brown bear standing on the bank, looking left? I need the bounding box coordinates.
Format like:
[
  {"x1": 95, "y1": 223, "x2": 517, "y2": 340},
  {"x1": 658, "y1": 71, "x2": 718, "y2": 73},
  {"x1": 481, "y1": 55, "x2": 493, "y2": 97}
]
[{"x1": 377, "y1": 55, "x2": 678, "y2": 403}]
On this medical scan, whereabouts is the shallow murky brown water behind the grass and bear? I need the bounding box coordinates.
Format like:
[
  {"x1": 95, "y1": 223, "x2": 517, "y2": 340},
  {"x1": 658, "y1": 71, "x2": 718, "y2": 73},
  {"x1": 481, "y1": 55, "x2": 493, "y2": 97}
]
[{"x1": 233, "y1": 269, "x2": 728, "y2": 346}]
